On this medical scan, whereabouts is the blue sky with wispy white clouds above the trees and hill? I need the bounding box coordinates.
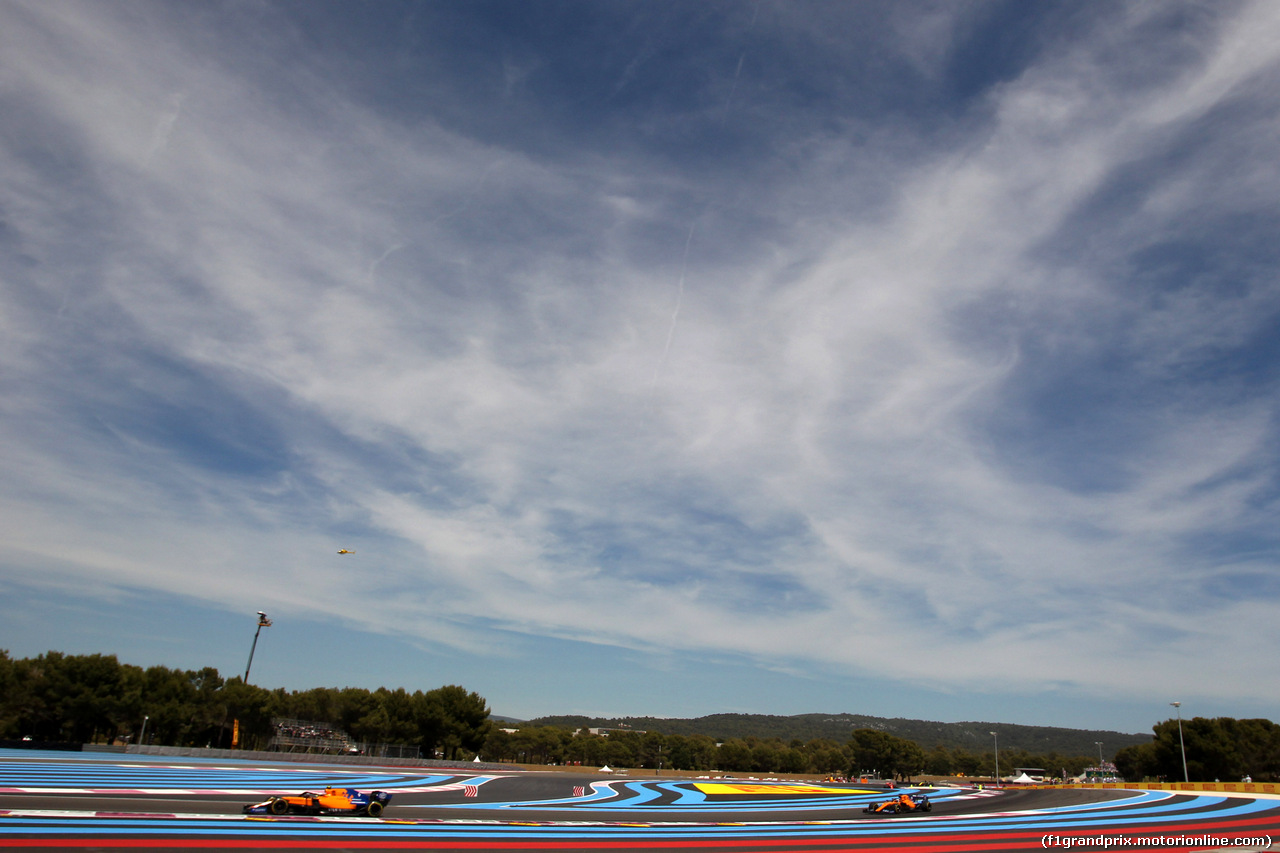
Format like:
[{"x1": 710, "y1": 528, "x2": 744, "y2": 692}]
[{"x1": 0, "y1": 0, "x2": 1280, "y2": 731}]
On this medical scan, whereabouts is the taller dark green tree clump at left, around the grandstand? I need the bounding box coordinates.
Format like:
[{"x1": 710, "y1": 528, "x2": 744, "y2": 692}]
[{"x1": 0, "y1": 649, "x2": 493, "y2": 758}]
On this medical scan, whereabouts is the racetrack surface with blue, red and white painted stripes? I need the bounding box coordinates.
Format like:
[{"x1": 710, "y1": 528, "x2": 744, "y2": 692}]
[{"x1": 0, "y1": 751, "x2": 1280, "y2": 853}]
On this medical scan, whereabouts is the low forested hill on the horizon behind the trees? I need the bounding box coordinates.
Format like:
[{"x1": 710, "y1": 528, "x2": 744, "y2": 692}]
[{"x1": 525, "y1": 713, "x2": 1153, "y2": 756}]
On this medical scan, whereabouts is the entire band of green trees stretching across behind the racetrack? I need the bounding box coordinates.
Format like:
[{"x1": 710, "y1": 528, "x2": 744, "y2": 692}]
[{"x1": 0, "y1": 649, "x2": 1280, "y2": 781}]
